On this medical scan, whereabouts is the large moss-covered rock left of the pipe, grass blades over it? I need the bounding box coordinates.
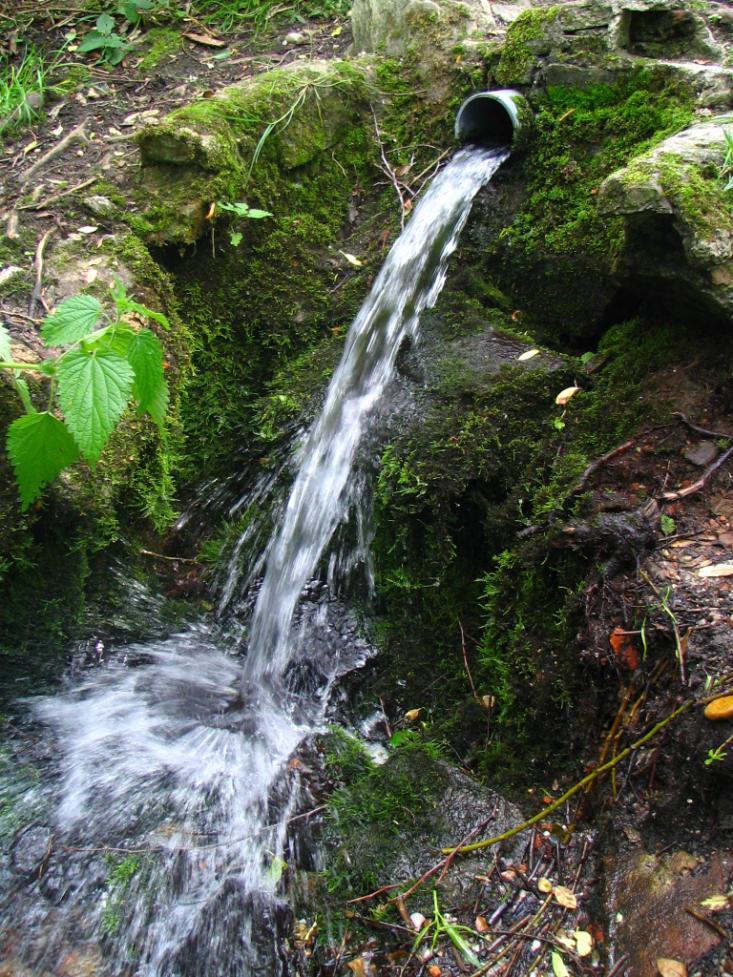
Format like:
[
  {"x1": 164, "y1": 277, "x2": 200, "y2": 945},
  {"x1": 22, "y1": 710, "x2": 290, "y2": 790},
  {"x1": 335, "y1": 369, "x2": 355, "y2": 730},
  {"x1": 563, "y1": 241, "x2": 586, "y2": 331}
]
[{"x1": 132, "y1": 60, "x2": 367, "y2": 245}]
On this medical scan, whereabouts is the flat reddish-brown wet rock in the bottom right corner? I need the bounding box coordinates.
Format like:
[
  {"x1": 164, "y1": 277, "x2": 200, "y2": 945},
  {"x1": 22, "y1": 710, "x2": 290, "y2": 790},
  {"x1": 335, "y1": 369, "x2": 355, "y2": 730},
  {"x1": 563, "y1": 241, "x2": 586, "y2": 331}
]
[{"x1": 606, "y1": 851, "x2": 733, "y2": 977}]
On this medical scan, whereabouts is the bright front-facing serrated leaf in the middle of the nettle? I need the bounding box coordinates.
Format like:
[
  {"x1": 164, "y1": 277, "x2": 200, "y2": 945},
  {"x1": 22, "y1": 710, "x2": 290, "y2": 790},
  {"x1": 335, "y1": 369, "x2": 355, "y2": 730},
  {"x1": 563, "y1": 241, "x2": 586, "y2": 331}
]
[{"x1": 58, "y1": 349, "x2": 135, "y2": 465}]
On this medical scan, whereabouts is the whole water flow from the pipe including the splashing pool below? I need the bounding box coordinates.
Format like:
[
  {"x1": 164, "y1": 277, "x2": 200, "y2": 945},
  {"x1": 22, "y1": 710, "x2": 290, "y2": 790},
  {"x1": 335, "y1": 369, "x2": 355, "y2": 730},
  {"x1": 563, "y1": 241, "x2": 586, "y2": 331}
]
[{"x1": 0, "y1": 148, "x2": 508, "y2": 977}]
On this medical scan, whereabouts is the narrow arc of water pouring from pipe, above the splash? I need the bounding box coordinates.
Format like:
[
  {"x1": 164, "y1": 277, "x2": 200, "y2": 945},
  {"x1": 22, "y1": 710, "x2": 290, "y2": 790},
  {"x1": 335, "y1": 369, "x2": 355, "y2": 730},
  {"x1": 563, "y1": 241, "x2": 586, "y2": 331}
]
[{"x1": 244, "y1": 148, "x2": 508, "y2": 686}]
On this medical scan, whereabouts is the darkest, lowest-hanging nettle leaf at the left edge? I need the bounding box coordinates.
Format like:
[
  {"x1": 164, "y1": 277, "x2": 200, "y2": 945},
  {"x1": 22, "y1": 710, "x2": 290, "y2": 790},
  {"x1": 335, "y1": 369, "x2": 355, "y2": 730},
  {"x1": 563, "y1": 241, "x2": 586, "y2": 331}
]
[{"x1": 7, "y1": 412, "x2": 79, "y2": 511}]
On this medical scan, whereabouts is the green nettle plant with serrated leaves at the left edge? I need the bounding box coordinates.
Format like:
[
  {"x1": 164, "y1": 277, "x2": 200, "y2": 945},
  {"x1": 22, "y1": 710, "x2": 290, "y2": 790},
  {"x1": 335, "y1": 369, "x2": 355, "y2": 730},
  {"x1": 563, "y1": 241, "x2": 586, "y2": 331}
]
[{"x1": 0, "y1": 282, "x2": 170, "y2": 511}]
